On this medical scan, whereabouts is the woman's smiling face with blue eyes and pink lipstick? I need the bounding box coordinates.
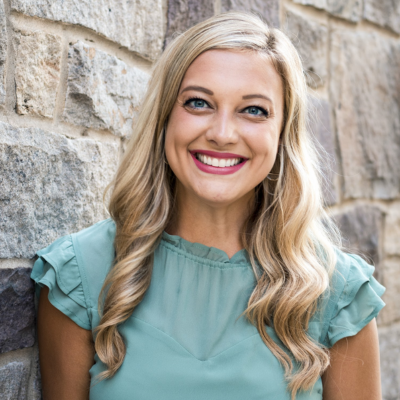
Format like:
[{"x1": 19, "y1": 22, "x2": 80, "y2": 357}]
[{"x1": 165, "y1": 50, "x2": 283, "y2": 206}]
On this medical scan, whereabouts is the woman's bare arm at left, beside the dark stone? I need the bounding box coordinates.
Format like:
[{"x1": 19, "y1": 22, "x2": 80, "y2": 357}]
[{"x1": 38, "y1": 287, "x2": 95, "y2": 400}]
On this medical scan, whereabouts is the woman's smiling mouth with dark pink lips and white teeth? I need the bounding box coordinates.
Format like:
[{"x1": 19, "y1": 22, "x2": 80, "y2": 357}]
[{"x1": 190, "y1": 150, "x2": 248, "y2": 175}]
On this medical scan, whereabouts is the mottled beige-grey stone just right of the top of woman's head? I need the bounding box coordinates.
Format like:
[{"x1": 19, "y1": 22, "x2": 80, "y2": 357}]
[{"x1": 285, "y1": 11, "x2": 328, "y2": 88}]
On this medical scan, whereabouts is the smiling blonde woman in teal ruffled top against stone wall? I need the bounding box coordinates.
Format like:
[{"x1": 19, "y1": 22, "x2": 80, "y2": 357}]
[{"x1": 32, "y1": 13, "x2": 384, "y2": 400}]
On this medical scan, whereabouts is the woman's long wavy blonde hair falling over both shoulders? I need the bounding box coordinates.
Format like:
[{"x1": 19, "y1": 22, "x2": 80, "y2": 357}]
[{"x1": 95, "y1": 12, "x2": 338, "y2": 398}]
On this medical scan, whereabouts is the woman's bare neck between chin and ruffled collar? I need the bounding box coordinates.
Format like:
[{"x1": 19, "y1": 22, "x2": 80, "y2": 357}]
[{"x1": 166, "y1": 183, "x2": 254, "y2": 258}]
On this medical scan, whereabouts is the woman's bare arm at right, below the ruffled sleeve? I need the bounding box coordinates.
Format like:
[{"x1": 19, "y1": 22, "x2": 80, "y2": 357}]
[{"x1": 322, "y1": 318, "x2": 382, "y2": 400}]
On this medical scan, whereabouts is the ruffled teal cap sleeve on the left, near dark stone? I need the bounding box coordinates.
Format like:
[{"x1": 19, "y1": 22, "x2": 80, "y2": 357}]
[{"x1": 31, "y1": 236, "x2": 91, "y2": 330}]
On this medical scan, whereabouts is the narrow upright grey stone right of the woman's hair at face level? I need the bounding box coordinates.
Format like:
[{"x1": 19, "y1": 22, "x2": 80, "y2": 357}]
[{"x1": 308, "y1": 96, "x2": 337, "y2": 206}]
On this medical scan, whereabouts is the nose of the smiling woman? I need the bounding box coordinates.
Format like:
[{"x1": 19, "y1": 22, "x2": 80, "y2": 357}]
[{"x1": 206, "y1": 110, "x2": 239, "y2": 147}]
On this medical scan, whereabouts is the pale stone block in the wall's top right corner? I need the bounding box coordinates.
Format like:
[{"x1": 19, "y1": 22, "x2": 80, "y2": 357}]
[{"x1": 363, "y1": 0, "x2": 400, "y2": 33}]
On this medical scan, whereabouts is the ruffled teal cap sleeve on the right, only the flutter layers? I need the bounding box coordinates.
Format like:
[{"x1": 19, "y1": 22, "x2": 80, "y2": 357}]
[{"x1": 325, "y1": 254, "x2": 385, "y2": 347}]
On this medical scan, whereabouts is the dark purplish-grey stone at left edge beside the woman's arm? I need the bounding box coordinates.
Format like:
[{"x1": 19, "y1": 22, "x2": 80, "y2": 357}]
[{"x1": 0, "y1": 268, "x2": 35, "y2": 353}]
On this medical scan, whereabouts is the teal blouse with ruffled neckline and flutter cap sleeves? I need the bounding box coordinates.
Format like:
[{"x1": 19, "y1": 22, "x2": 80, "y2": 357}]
[{"x1": 31, "y1": 219, "x2": 384, "y2": 400}]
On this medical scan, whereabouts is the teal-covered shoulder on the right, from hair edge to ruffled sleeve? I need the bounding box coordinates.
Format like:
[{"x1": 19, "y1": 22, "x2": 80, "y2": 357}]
[{"x1": 314, "y1": 250, "x2": 385, "y2": 347}]
